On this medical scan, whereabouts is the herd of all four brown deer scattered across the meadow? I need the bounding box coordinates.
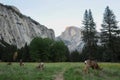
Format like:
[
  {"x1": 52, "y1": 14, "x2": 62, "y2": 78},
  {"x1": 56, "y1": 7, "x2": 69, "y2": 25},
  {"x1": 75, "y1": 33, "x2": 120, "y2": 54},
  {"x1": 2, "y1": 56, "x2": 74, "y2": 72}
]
[{"x1": 8, "y1": 59, "x2": 102, "y2": 73}]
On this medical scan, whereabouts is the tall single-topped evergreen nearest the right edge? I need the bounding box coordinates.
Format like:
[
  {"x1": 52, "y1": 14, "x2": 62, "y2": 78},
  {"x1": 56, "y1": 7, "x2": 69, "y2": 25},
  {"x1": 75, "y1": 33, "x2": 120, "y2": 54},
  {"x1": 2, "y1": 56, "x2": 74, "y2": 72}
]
[{"x1": 101, "y1": 6, "x2": 119, "y2": 61}]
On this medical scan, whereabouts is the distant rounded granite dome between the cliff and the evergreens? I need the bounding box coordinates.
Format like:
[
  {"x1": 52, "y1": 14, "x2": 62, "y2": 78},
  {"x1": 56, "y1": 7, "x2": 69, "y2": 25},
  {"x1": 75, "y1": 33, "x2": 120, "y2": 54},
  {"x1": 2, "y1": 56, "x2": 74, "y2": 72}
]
[{"x1": 57, "y1": 26, "x2": 84, "y2": 52}]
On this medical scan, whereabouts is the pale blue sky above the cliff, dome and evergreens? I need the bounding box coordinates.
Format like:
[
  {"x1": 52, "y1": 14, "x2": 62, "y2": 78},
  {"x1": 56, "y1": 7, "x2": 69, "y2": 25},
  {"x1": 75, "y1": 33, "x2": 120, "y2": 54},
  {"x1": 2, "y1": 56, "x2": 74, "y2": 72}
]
[{"x1": 0, "y1": 0, "x2": 120, "y2": 36}]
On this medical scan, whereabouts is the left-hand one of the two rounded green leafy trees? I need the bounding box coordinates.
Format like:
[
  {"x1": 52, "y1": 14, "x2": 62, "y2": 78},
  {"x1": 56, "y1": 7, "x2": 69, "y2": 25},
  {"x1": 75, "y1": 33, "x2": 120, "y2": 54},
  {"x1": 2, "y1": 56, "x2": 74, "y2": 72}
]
[{"x1": 30, "y1": 37, "x2": 53, "y2": 61}]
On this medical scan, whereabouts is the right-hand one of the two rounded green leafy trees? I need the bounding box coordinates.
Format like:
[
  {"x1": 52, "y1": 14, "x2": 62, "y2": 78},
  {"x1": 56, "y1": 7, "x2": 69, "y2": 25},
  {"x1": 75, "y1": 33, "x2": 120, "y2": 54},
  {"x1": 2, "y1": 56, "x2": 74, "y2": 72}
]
[{"x1": 50, "y1": 41, "x2": 69, "y2": 62}]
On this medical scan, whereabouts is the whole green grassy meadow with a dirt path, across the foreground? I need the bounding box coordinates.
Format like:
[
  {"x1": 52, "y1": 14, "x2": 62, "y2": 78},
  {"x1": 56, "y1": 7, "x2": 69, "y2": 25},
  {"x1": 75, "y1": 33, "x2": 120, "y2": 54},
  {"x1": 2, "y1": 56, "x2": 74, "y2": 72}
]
[{"x1": 0, "y1": 62, "x2": 120, "y2": 80}]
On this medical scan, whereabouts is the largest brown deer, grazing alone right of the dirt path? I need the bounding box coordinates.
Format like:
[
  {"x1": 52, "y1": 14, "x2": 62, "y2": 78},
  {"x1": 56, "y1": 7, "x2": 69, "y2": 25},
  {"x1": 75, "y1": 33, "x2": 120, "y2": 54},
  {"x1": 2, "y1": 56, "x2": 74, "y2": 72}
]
[{"x1": 84, "y1": 59, "x2": 101, "y2": 72}]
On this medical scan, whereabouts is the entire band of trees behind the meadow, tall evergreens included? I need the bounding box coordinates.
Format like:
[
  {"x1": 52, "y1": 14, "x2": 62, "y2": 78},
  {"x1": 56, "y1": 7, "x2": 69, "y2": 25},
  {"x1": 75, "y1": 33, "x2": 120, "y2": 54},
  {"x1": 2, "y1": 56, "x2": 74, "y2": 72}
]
[{"x1": 0, "y1": 6, "x2": 120, "y2": 62}]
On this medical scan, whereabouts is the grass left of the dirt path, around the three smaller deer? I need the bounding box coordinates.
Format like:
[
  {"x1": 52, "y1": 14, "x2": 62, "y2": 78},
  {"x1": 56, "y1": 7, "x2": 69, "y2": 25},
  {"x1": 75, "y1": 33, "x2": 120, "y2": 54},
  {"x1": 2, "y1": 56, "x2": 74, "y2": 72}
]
[{"x1": 0, "y1": 63, "x2": 62, "y2": 80}]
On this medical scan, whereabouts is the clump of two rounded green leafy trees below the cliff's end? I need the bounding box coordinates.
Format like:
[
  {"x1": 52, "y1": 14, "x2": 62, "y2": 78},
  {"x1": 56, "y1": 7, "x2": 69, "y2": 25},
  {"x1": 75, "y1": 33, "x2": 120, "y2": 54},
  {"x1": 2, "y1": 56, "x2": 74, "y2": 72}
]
[{"x1": 30, "y1": 37, "x2": 69, "y2": 62}]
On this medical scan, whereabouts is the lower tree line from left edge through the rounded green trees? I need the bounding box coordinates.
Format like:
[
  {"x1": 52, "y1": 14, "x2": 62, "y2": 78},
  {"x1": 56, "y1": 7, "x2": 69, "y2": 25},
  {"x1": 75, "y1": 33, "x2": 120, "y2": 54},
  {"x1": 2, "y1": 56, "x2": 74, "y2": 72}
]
[{"x1": 0, "y1": 37, "x2": 69, "y2": 62}]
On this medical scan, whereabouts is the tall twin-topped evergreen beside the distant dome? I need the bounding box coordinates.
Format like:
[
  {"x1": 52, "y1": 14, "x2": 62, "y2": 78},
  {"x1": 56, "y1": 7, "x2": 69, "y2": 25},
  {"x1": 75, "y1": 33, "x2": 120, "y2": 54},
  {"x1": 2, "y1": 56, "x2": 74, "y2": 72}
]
[{"x1": 82, "y1": 10, "x2": 97, "y2": 58}]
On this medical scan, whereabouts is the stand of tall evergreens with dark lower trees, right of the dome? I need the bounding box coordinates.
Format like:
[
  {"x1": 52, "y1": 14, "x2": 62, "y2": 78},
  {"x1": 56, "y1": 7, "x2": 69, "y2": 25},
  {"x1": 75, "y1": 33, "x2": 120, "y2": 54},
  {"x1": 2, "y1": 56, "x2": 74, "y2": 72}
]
[{"x1": 81, "y1": 6, "x2": 120, "y2": 62}]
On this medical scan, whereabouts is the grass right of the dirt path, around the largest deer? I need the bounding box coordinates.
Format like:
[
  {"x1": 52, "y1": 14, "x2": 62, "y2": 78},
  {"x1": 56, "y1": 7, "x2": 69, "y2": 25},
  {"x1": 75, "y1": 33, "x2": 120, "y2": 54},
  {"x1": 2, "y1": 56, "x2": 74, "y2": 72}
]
[{"x1": 64, "y1": 63, "x2": 120, "y2": 80}]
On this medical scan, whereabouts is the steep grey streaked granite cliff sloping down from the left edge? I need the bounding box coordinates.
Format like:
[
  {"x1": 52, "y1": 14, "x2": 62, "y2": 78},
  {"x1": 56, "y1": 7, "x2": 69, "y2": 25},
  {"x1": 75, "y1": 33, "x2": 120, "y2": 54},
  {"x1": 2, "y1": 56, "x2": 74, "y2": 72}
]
[{"x1": 0, "y1": 4, "x2": 55, "y2": 48}]
